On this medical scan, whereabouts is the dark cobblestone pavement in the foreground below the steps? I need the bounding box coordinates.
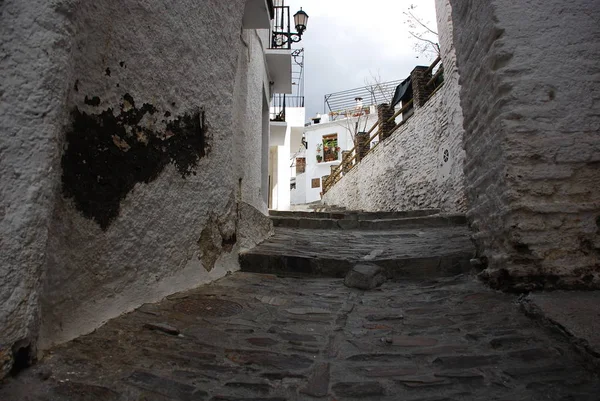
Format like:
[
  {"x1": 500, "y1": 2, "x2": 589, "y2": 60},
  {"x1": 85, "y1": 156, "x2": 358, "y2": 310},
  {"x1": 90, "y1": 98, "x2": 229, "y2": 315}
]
[{"x1": 0, "y1": 273, "x2": 600, "y2": 401}]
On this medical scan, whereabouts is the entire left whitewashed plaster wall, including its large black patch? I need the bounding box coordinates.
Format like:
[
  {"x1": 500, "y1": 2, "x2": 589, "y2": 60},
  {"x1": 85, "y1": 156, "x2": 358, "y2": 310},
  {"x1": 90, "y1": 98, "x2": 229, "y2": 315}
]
[{"x1": 0, "y1": 0, "x2": 270, "y2": 373}]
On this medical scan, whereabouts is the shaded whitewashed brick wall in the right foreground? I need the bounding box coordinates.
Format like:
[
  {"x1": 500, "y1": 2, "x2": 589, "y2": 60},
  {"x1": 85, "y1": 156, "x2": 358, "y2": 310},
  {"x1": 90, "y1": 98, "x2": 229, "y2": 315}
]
[{"x1": 451, "y1": 0, "x2": 600, "y2": 290}]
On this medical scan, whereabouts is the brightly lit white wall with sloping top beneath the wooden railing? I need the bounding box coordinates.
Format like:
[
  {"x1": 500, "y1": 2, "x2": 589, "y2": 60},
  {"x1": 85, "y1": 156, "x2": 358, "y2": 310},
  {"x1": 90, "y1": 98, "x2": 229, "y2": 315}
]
[{"x1": 323, "y1": 0, "x2": 467, "y2": 216}]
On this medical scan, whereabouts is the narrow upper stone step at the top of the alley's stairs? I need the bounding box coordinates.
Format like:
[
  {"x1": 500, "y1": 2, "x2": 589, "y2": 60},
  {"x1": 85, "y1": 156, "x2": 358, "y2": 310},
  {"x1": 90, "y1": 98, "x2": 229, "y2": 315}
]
[{"x1": 271, "y1": 212, "x2": 467, "y2": 230}]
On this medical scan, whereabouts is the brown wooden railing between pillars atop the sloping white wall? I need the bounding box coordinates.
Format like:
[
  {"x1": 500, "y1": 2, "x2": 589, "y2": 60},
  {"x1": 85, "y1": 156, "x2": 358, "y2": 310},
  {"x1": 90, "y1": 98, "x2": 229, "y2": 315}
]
[{"x1": 323, "y1": 56, "x2": 444, "y2": 194}]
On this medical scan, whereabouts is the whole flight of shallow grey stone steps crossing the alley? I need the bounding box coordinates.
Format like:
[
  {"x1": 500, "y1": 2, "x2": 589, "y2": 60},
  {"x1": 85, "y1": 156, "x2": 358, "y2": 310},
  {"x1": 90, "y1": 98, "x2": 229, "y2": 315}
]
[{"x1": 240, "y1": 207, "x2": 474, "y2": 279}]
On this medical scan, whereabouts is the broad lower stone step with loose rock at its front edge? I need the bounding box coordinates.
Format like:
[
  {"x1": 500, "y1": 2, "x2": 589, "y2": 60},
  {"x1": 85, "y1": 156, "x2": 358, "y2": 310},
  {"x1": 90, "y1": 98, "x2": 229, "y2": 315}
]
[{"x1": 240, "y1": 225, "x2": 474, "y2": 279}]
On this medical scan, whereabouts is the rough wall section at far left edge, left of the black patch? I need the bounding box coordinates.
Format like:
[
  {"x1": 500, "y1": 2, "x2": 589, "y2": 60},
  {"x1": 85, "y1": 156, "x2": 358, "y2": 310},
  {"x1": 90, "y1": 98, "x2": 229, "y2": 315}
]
[{"x1": 0, "y1": 0, "x2": 70, "y2": 377}]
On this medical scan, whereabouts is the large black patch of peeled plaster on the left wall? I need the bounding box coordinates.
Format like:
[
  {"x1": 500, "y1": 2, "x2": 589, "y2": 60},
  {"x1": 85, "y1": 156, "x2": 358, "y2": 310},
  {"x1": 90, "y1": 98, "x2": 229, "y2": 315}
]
[{"x1": 61, "y1": 94, "x2": 210, "y2": 230}]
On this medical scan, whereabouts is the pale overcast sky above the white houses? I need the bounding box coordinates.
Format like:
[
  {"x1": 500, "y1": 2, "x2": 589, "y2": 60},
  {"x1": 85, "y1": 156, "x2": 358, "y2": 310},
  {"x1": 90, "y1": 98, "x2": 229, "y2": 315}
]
[{"x1": 285, "y1": 0, "x2": 437, "y2": 121}]
